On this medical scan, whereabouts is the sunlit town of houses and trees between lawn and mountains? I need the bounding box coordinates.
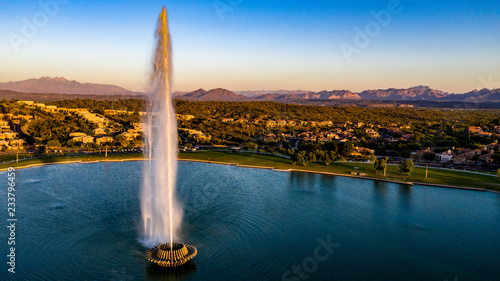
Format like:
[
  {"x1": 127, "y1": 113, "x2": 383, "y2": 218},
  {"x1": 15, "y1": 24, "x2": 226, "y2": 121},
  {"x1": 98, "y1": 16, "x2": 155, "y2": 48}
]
[{"x1": 0, "y1": 100, "x2": 500, "y2": 170}]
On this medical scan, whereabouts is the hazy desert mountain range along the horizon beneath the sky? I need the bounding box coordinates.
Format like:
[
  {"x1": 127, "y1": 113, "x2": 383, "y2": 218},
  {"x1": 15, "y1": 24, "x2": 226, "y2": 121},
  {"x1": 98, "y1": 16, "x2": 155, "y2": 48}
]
[{"x1": 0, "y1": 77, "x2": 500, "y2": 103}]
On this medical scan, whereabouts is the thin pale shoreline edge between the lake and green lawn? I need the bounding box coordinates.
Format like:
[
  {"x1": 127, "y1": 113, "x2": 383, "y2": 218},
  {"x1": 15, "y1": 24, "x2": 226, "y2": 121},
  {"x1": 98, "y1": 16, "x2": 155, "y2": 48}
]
[{"x1": 0, "y1": 154, "x2": 500, "y2": 194}]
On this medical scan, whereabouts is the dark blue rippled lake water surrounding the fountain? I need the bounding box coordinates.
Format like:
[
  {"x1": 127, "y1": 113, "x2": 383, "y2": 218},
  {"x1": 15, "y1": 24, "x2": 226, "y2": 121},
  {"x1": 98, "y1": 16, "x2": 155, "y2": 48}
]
[{"x1": 0, "y1": 162, "x2": 500, "y2": 281}]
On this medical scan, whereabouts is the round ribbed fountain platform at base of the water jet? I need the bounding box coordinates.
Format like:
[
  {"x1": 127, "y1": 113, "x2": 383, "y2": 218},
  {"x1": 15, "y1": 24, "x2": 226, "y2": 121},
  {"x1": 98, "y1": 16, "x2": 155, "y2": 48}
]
[{"x1": 146, "y1": 242, "x2": 198, "y2": 267}]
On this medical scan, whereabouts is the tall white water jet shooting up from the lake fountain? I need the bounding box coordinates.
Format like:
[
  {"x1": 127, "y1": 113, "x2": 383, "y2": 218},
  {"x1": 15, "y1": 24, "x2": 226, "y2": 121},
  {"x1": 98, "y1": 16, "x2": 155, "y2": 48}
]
[{"x1": 141, "y1": 7, "x2": 182, "y2": 247}]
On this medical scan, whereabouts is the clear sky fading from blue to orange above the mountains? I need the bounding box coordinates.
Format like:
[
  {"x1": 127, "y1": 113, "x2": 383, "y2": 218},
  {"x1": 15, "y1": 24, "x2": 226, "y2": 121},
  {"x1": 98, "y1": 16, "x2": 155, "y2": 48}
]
[{"x1": 0, "y1": 0, "x2": 500, "y2": 93}]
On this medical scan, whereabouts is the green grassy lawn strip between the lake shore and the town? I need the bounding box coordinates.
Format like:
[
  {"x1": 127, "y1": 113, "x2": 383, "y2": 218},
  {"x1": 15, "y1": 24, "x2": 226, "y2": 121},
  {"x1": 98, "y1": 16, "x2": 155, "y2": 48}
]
[{"x1": 0, "y1": 151, "x2": 500, "y2": 191}]
